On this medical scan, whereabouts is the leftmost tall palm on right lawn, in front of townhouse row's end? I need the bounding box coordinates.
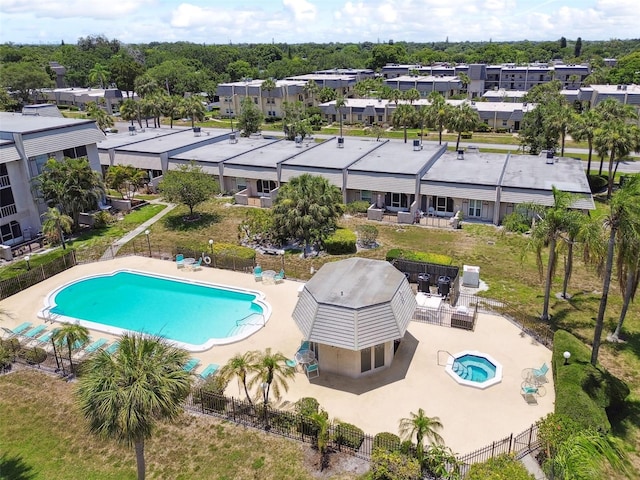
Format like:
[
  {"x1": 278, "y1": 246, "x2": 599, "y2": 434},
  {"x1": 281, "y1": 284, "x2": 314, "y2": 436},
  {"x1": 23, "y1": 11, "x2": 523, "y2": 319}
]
[{"x1": 531, "y1": 185, "x2": 575, "y2": 321}]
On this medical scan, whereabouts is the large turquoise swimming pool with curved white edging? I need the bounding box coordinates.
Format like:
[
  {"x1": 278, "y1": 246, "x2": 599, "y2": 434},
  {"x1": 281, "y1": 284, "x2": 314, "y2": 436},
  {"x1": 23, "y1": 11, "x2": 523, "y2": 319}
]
[{"x1": 39, "y1": 270, "x2": 271, "y2": 352}]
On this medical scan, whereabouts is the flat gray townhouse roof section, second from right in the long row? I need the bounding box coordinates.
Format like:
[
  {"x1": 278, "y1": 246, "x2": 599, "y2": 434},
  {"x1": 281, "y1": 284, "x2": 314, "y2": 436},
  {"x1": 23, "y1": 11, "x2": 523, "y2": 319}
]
[{"x1": 422, "y1": 152, "x2": 507, "y2": 186}]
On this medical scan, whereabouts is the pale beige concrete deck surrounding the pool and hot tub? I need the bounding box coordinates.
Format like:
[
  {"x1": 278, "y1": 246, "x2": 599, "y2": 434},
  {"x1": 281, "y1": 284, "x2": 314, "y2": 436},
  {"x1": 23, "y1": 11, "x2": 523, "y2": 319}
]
[{"x1": 0, "y1": 256, "x2": 555, "y2": 454}]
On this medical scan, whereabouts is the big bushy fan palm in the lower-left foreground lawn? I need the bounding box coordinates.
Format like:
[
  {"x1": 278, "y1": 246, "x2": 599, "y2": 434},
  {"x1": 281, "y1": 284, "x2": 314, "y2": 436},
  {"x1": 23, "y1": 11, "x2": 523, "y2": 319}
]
[{"x1": 76, "y1": 334, "x2": 191, "y2": 480}]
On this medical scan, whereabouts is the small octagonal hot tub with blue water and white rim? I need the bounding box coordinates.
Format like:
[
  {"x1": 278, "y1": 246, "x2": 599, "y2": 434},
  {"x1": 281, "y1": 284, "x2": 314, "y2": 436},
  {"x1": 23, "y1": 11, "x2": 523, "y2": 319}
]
[{"x1": 445, "y1": 350, "x2": 502, "y2": 389}]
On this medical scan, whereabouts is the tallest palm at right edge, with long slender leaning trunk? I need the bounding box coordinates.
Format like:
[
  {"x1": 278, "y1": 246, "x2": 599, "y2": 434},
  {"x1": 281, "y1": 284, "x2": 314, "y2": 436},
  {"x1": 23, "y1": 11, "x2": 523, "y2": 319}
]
[{"x1": 591, "y1": 175, "x2": 640, "y2": 367}]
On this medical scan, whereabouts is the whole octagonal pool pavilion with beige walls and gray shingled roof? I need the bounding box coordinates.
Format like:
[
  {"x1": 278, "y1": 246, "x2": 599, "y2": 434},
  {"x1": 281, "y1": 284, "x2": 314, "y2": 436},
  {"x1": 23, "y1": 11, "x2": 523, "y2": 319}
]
[{"x1": 293, "y1": 258, "x2": 417, "y2": 378}]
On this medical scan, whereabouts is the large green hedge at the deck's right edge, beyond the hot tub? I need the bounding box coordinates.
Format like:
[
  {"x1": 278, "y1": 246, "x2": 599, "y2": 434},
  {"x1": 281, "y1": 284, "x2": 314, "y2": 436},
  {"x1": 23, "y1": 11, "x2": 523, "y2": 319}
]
[{"x1": 553, "y1": 330, "x2": 629, "y2": 433}]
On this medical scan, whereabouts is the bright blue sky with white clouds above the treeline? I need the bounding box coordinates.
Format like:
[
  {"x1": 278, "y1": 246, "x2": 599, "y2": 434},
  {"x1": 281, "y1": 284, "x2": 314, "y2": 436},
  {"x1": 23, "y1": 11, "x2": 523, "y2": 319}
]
[{"x1": 0, "y1": 0, "x2": 640, "y2": 44}]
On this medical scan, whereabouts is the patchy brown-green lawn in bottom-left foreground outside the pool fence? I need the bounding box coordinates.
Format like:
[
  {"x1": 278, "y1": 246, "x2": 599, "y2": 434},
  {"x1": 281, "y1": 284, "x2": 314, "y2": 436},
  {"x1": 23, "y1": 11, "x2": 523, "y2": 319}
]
[{"x1": 0, "y1": 371, "x2": 357, "y2": 480}]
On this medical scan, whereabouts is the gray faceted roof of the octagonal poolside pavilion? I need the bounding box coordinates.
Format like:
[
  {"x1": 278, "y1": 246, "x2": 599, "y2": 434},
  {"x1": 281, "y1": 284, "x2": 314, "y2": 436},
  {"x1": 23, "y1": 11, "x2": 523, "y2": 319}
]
[{"x1": 293, "y1": 258, "x2": 416, "y2": 350}]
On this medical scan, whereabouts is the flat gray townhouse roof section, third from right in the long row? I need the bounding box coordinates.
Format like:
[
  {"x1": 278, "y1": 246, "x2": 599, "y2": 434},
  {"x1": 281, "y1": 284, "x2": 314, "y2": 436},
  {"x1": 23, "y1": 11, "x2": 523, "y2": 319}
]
[{"x1": 345, "y1": 138, "x2": 441, "y2": 175}]
